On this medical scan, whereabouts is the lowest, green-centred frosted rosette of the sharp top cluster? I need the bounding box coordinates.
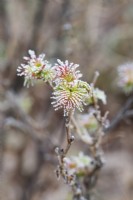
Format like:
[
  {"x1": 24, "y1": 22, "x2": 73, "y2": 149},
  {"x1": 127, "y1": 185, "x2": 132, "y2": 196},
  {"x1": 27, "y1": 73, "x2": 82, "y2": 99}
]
[{"x1": 51, "y1": 81, "x2": 88, "y2": 116}]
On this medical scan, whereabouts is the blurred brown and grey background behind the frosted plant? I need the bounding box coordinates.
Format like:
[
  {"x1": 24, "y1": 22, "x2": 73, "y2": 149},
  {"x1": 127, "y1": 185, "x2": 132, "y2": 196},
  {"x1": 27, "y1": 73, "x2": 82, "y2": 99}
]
[{"x1": 0, "y1": 0, "x2": 133, "y2": 200}]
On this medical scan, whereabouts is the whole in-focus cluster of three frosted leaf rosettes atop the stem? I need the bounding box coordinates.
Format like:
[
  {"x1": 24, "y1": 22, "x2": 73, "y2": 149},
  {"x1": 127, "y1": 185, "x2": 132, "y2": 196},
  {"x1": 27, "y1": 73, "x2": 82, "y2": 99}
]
[{"x1": 17, "y1": 50, "x2": 92, "y2": 116}]
